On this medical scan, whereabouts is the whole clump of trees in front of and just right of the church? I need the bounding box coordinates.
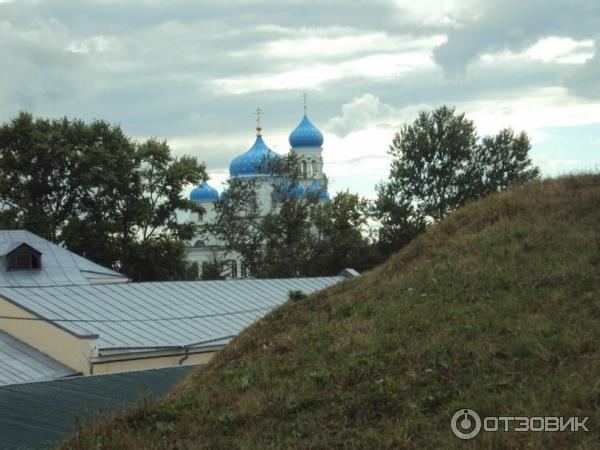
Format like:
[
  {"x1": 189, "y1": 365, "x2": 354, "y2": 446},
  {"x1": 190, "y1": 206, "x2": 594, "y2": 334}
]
[{"x1": 204, "y1": 153, "x2": 375, "y2": 277}]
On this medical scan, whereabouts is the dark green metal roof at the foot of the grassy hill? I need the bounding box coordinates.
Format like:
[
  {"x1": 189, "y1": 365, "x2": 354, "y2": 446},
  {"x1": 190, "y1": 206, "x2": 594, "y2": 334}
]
[{"x1": 0, "y1": 366, "x2": 193, "y2": 450}]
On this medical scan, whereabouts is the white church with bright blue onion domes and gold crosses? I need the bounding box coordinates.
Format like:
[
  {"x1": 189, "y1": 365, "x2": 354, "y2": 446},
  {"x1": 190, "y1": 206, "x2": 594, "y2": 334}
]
[{"x1": 187, "y1": 105, "x2": 329, "y2": 278}]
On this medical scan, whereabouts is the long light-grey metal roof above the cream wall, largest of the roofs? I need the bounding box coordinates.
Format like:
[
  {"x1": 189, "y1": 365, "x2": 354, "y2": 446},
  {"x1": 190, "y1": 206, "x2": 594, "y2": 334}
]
[{"x1": 0, "y1": 277, "x2": 344, "y2": 349}]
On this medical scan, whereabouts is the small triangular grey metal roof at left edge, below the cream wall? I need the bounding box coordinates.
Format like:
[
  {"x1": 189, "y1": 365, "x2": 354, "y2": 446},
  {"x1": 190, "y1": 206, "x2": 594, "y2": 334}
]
[{"x1": 0, "y1": 331, "x2": 75, "y2": 386}]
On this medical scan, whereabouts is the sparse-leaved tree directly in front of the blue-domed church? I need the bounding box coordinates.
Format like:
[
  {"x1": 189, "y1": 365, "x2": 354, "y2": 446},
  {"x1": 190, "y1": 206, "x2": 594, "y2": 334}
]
[{"x1": 201, "y1": 154, "x2": 318, "y2": 277}]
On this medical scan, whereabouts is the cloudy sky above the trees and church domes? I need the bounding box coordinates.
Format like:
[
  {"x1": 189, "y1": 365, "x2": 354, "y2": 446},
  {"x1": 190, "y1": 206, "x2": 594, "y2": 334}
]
[{"x1": 0, "y1": 0, "x2": 600, "y2": 197}]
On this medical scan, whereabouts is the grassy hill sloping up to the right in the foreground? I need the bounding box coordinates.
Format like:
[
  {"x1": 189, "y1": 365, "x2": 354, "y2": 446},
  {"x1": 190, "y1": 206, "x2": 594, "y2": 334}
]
[{"x1": 63, "y1": 175, "x2": 600, "y2": 449}]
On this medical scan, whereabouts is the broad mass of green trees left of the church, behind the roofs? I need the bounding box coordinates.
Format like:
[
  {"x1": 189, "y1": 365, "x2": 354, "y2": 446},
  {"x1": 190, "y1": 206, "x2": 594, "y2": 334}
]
[{"x1": 0, "y1": 113, "x2": 206, "y2": 280}]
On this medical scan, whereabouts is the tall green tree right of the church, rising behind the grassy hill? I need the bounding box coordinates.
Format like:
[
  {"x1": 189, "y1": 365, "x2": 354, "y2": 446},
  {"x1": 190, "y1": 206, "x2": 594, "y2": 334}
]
[{"x1": 374, "y1": 106, "x2": 539, "y2": 253}]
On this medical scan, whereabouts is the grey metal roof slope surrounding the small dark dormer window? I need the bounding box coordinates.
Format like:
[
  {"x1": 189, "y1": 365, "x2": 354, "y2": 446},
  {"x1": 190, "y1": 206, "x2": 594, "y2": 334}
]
[{"x1": 0, "y1": 230, "x2": 127, "y2": 287}]
